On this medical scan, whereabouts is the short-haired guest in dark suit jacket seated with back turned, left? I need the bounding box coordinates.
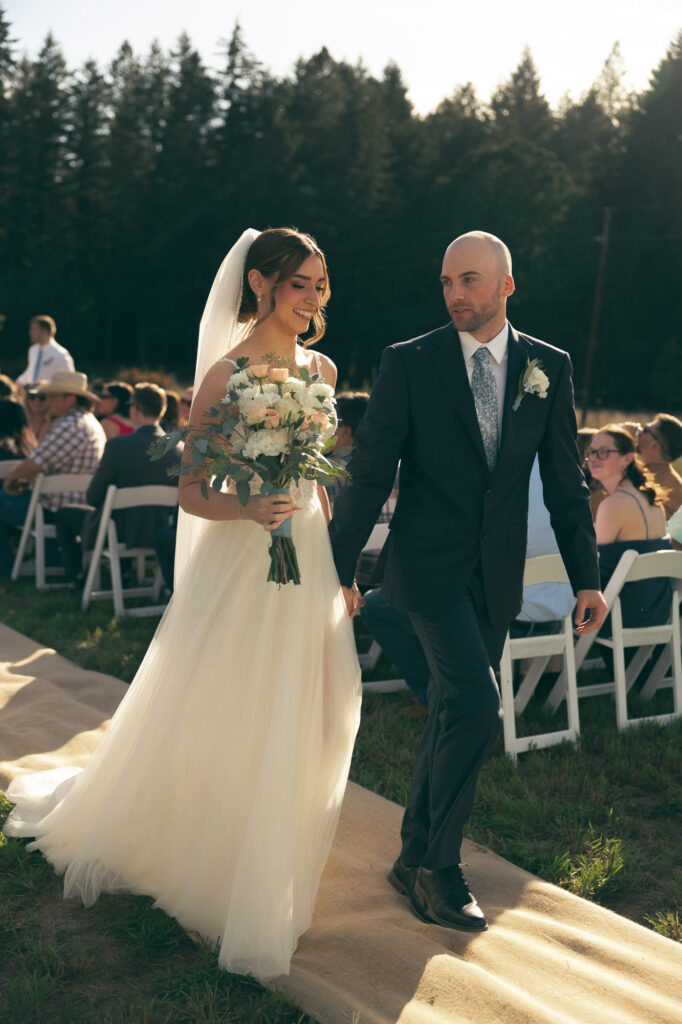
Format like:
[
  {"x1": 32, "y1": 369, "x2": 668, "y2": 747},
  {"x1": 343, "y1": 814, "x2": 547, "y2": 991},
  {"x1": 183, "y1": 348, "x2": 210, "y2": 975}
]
[{"x1": 55, "y1": 384, "x2": 181, "y2": 585}]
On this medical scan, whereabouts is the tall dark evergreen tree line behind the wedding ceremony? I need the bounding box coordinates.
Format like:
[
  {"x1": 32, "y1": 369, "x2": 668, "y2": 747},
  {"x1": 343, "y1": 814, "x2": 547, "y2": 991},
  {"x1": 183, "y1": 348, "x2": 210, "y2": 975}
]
[{"x1": 0, "y1": 7, "x2": 682, "y2": 411}]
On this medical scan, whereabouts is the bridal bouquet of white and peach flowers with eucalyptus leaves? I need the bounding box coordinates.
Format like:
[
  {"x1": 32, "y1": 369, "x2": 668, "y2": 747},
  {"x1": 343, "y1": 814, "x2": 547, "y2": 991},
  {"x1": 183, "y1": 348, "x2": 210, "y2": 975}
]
[{"x1": 153, "y1": 358, "x2": 348, "y2": 584}]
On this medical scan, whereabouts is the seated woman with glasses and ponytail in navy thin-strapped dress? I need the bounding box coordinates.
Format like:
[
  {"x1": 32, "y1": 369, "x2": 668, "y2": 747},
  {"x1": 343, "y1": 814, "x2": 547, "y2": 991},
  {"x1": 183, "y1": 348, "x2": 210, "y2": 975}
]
[{"x1": 587, "y1": 424, "x2": 671, "y2": 635}]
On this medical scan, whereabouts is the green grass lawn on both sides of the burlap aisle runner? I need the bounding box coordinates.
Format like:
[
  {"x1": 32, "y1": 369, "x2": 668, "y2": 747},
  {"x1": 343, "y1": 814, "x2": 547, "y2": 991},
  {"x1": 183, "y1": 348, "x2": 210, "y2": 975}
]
[{"x1": 0, "y1": 581, "x2": 682, "y2": 1024}]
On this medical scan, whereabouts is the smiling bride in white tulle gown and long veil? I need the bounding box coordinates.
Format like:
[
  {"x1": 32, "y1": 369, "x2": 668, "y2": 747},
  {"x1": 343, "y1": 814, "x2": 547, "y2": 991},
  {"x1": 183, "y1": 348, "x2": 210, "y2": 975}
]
[{"x1": 4, "y1": 228, "x2": 360, "y2": 980}]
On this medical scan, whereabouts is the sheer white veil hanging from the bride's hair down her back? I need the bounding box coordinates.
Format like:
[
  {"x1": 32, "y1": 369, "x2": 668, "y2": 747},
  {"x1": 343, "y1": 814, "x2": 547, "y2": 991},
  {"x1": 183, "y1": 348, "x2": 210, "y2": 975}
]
[{"x1": 175, "y1": 227, "x2": 260, "y2": 583}]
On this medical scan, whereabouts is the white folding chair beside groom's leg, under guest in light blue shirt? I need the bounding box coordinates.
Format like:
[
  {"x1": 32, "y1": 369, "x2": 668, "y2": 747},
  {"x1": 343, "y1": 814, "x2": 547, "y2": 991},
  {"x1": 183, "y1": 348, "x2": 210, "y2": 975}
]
[{"x1": 500, "y1": 555, "x2": 581, "y2": 762}]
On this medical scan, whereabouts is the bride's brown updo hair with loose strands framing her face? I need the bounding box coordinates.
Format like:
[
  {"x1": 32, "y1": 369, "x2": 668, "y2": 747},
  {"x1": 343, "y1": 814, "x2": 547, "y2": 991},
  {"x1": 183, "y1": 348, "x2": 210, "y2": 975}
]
[{"x1": 239, "y1": 227, "x2": 331, "y2": 348}]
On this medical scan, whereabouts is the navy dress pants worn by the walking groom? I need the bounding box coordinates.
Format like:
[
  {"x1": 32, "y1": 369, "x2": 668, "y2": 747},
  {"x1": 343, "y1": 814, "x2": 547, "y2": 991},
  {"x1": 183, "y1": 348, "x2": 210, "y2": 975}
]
[{"x1": 401, "y1": 569, "x2": 507, "y2": 870}]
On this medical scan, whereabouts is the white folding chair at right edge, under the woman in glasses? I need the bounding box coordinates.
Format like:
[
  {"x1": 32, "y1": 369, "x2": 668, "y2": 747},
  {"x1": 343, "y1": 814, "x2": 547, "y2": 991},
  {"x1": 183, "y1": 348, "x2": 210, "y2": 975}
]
[{"x1": 597, "y1": 551, "x2": 682, "y2": 730}]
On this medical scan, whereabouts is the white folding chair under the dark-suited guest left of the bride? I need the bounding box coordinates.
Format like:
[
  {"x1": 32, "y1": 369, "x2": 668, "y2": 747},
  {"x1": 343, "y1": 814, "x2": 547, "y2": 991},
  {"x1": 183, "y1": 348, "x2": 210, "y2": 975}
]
[{"x1": 81, "y1": 483, "x2": 177, "y2": 617}]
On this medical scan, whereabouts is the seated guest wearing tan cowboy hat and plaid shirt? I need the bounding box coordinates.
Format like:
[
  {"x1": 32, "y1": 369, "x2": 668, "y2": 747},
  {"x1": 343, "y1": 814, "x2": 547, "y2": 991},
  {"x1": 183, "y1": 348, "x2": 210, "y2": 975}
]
[{"x1": 0, "y1": 370, "x2": 106, "y2": 575}]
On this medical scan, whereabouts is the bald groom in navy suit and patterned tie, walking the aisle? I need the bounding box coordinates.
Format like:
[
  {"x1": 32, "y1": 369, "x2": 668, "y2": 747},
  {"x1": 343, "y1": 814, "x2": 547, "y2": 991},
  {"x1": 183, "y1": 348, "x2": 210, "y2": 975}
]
[{"x1": 330, "y1": 231, "x2": 606, "y2": 931}]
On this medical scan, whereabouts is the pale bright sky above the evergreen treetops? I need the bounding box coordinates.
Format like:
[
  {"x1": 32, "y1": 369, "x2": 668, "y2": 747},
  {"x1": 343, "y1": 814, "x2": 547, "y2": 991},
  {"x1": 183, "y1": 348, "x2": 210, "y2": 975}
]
[{"x1": 6, "y1": 0, "x2": 682, "y2": 114}]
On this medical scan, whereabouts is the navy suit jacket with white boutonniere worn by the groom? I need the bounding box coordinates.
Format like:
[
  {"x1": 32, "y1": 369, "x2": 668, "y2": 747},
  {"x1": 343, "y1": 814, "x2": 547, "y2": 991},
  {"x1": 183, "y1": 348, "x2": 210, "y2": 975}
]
[{"x1": 330, "y1": 324, "x2": 599, "y2": 626}]
